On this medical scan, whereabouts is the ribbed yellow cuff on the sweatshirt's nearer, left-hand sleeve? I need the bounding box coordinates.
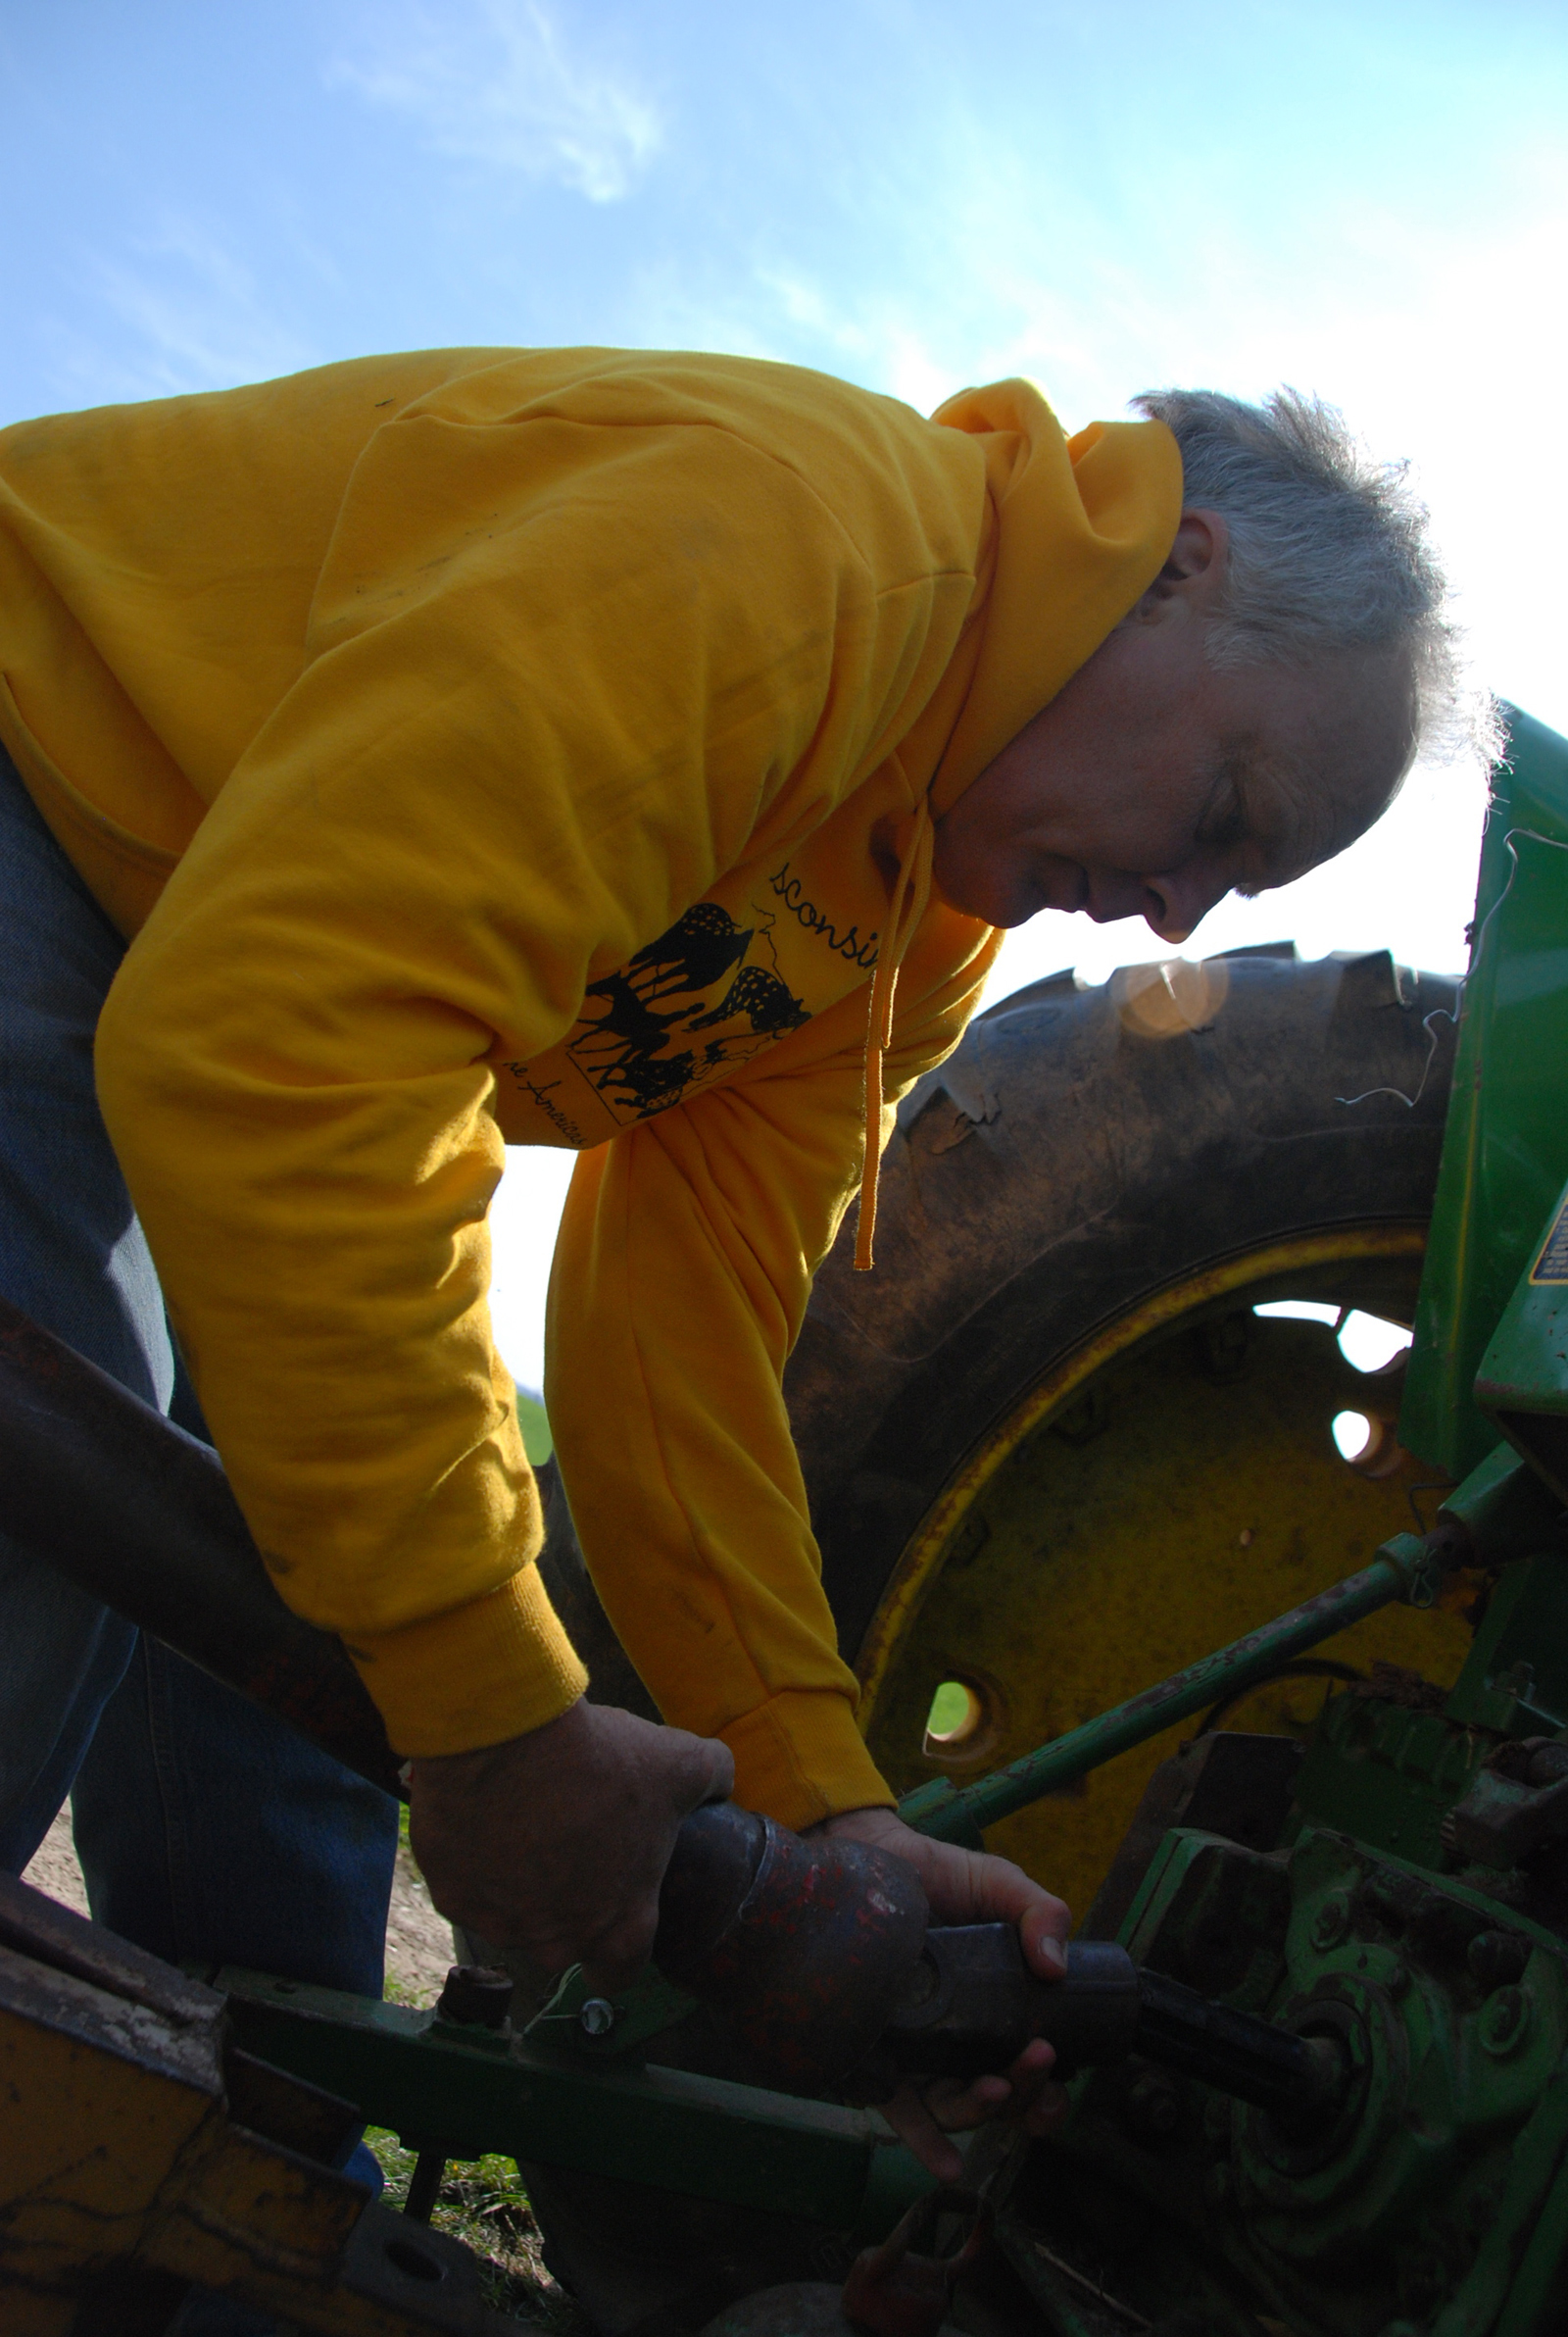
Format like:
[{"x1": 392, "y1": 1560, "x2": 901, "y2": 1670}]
[{"x1": 346, "y1": 1566, "x2": 589, "y2": 1760}]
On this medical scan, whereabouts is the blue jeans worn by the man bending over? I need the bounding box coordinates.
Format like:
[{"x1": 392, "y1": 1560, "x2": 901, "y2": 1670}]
[{"x1": 0, "y1": 750, "x2": 397, "y2": 2206}]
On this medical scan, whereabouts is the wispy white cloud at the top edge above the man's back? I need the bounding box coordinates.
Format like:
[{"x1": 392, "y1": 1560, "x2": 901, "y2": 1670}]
[{"x1": 329, "y1": 0, "x2": 663, "y2": 203}]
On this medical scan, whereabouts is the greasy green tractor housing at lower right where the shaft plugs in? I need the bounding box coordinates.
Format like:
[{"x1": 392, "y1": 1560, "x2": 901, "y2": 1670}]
[{"x1": 1042, "y1": 1827, "x2": 1568, "y2": 2337}]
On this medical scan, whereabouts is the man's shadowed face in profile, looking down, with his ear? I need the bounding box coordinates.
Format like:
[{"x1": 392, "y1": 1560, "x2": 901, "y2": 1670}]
[{"x1": 935, "y1": 512, "x2": 1414, "y2": 942}]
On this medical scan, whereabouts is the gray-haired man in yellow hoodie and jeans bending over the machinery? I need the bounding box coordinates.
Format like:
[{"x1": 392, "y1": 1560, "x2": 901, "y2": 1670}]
[{"x1": 0, "y1": 351, "x2": 1451, "y2": 2166}]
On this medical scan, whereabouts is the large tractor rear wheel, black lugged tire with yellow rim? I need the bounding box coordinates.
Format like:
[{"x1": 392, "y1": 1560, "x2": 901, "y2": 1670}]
[{"x1": 785, "y1": 944, "x2": 1463, "y2": 1910}]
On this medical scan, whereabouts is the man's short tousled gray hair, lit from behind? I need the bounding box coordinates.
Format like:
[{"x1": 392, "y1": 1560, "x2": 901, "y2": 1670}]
[{"x1": 1133, "y1": 388, "x2": 1494, "y2": 753}]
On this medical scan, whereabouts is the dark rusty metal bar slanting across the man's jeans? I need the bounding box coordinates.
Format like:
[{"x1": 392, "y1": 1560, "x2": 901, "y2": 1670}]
[{"x1": 0, "y1": 1300, "x2": 400, "y2": 1793}]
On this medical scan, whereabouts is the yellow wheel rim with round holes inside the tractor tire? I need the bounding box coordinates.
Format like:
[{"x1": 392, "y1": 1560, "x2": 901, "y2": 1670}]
[{"x1": 859, "y1": 1224, "x2": 1467, "y2": 1914}]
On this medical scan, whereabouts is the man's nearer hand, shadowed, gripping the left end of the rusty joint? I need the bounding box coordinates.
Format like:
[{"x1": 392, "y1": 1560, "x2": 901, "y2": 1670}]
[{"x1": 409, "y1": 1699, "x2": 736, "y2": 1994}]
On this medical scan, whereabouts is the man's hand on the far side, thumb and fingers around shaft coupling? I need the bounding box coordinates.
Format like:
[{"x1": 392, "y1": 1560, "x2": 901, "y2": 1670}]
[{"x1": 810, "y1": 1809, "x2": 1072, "y2": 2183}]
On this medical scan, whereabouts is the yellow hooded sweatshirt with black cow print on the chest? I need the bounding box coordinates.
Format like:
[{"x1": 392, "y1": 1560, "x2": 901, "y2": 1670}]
[{"x1": 0, "y1": 351, "x2": 1180, "y2": 1825}]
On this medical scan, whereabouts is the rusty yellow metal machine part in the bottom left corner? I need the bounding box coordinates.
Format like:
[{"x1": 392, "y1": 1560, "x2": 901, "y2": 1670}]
[{"x1": 0, "y1": 1876, "x2": 516, "y2": 2337}]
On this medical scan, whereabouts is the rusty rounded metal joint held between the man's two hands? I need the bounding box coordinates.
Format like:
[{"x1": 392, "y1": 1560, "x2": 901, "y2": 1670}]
[{"x1": 655, "y1": 1802, "x2": 930, "y2": 2089}]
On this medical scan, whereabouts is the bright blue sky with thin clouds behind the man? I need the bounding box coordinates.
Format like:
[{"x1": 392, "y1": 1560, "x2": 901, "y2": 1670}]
[{"x1": 0, "y1": 0, "x2": 1568, "y2": 1379}]
